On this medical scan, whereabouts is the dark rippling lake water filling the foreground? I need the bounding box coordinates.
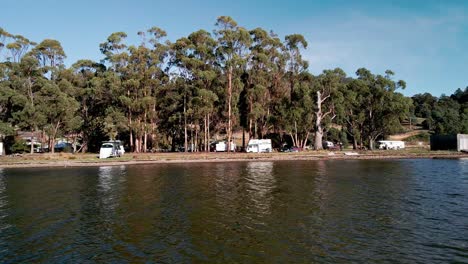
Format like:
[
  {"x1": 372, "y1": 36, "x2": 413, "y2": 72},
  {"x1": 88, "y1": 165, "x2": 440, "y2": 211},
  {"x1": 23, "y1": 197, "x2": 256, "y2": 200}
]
[{"x1": 0, "y1": 159, "x2": 468, "y2": 263}]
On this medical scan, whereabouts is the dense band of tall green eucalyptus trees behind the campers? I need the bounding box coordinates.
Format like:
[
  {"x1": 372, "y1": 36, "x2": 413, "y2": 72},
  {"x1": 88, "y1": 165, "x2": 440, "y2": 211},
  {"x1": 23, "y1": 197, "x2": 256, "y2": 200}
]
[{"x1": 0, "y1": 17, "x2": 468, "y2": 152}]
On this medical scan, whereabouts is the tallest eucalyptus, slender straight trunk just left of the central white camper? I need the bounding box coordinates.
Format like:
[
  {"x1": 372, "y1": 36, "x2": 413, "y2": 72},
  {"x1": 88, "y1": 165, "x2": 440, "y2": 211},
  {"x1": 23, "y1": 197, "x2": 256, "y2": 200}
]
[{"x1": 214, "y1": 16, "x2": 251, "y2": 151}]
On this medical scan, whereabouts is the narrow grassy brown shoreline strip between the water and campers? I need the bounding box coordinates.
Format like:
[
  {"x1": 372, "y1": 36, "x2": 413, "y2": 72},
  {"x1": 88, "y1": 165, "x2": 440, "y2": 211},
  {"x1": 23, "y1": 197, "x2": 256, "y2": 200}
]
[{"x1": 0, "y1": 152, "x2": 468, "y2": 168}]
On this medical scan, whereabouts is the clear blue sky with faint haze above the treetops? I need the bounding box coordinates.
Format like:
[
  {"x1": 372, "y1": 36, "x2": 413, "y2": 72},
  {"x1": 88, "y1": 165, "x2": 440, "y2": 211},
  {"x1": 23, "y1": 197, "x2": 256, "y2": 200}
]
[{"x1": 0, "y1": 0, "x2": 468, "y2": 96}]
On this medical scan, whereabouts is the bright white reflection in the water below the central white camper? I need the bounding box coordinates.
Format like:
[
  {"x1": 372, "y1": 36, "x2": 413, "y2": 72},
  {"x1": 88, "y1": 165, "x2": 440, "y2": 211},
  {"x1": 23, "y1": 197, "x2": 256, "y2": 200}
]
[{"x1": 245, "y1": 162, "x2": 276, "y2": 215}]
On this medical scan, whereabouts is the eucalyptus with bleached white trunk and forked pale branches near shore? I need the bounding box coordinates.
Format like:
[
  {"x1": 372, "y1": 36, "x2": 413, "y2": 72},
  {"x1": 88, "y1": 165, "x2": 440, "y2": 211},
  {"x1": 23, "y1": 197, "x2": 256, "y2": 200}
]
[{"x1": 314, "y1": 68, "x2": 346, "y2": 150}]
